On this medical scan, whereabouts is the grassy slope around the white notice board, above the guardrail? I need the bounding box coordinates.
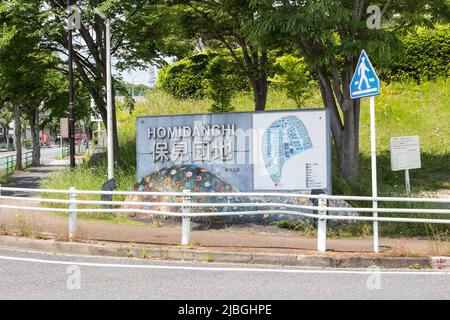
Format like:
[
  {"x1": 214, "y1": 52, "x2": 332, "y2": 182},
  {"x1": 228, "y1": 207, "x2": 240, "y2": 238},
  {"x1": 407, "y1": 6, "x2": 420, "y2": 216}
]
[{"x1": 356, "y1": 80, "x2": 450, "y2": 195}]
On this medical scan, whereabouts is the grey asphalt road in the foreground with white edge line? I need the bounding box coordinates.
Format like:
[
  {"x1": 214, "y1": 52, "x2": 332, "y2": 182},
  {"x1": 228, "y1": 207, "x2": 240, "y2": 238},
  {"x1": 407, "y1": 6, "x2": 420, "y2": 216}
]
[{"x1": 0, "y1": 248, "x2": 450, "y2": 300}]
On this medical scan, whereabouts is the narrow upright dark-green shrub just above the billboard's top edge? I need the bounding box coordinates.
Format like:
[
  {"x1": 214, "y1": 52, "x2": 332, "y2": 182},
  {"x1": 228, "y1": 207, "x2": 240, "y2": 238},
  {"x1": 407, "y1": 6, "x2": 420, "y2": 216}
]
[{"x1": 203, "y1": 55, "x2": 238, "y2": 113}]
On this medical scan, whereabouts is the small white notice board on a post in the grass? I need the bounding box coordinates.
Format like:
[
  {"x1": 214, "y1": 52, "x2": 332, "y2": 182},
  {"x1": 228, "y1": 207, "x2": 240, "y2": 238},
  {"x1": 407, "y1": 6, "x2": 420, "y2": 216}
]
[{"x1": 391, "y1": 136, "x2": 422, "y2": 171}]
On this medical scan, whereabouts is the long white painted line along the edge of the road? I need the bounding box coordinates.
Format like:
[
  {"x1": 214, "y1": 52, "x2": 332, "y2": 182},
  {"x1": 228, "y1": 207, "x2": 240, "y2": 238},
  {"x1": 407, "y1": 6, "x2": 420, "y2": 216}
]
[{"x1": 0, "y1": 256, "x2": 450, "y2": 276}]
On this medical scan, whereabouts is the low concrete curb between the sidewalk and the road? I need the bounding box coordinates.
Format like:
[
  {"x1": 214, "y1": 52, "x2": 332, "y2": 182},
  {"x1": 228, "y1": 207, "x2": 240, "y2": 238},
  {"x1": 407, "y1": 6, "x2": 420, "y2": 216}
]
[{"x1": 0, "y1": 236, "x2": 444, "y2": 269}]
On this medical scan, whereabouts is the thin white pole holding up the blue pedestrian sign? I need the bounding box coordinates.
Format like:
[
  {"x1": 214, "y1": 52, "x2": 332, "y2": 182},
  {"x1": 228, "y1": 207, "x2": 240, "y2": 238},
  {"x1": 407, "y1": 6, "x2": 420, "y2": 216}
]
[{"x1": 370, "y1": 96, "x2": 379, "y2": 253}]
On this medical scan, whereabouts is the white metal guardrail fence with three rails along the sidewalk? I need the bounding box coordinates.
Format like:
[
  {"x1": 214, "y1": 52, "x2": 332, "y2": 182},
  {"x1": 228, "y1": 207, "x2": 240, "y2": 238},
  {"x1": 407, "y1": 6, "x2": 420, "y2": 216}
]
[{"x1": 0, "y1": 186, "x2": 450, "y2": 252}]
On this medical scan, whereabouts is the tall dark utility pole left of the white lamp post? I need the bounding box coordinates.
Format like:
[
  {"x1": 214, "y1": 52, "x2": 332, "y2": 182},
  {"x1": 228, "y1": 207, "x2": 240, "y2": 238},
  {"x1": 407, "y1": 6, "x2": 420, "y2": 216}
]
[{"x1": 67, "y1": 0, "x2": 75, "y2": 168}]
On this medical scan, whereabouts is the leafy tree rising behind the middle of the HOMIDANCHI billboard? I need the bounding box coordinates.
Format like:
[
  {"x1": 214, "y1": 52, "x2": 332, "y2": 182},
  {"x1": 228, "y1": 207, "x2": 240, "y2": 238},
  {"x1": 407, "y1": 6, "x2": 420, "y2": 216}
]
[{"x1": 173, "y1": 0, "x2": 275, "y2": 111}]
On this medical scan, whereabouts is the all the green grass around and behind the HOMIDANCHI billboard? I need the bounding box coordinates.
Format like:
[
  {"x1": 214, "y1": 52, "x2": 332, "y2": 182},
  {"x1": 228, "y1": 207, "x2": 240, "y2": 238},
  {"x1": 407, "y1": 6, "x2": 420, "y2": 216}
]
[{"x1": 41, "y1": 80, "x2": 450, "y2": 237}]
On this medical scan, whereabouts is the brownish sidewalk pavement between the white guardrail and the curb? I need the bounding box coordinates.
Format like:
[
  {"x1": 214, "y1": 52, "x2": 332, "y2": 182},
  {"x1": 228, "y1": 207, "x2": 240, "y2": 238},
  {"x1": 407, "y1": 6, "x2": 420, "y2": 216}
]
[{"x1": 0, "y1": 200, "x2": 450, "y2": 257}]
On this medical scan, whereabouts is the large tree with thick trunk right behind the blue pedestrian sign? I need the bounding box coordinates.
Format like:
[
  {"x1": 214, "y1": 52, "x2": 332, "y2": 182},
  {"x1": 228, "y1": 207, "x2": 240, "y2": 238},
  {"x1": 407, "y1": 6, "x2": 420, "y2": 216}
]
[{"x1": 249, "y1": 0, "x2": 450, "y2": 180}]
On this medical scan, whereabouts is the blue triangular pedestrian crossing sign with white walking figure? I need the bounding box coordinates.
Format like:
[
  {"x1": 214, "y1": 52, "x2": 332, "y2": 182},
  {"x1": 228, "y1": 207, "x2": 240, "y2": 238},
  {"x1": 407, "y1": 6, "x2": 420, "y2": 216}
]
[{"x1": 350, "y1": 50, "x2": 380, "y2": 99}]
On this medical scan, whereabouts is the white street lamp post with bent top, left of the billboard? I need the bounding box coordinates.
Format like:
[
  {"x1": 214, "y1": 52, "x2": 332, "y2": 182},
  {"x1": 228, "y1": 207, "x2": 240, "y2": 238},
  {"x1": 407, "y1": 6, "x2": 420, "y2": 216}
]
[{"x1": 94, "y1": 8, "x2": 114, "y2": 180}]
